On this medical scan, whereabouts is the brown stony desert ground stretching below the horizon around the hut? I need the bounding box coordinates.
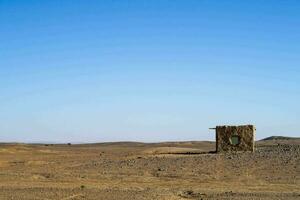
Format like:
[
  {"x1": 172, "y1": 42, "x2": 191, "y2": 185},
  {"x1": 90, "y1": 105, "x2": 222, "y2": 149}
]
[{"x1": 0, "y1": 139, "x2": 300, "y2": 200}]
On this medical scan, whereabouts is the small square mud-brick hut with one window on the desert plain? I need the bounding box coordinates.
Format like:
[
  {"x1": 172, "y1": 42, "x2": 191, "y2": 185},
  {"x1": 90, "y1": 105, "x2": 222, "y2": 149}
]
[{"x1": 213, "y1": 125, "x2": 256, "y2": 152}]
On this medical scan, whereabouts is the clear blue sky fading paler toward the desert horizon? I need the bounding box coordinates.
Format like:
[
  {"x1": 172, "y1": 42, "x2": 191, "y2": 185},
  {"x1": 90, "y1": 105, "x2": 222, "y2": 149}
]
[{"x1": 0, "y1": 0, "x2": 300, "y2": 142}]
